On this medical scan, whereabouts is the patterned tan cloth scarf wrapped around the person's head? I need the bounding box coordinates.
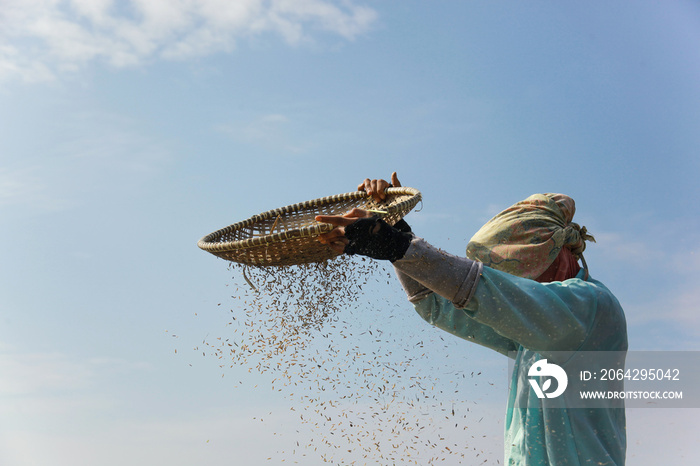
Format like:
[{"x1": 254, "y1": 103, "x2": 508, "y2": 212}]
[{"x1": 467, "y1": 194, "x2": 595, "y2": 279}]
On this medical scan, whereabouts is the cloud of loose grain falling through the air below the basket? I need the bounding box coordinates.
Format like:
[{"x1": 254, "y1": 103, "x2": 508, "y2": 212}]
[{"x1": 197, "y1": 256, "x2": 492, "y2": 465}]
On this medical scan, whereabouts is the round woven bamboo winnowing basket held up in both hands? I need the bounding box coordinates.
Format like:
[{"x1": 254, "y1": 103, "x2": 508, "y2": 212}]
[{"x1": 197, "y1": 187, "x2": 421, "y2": 266}]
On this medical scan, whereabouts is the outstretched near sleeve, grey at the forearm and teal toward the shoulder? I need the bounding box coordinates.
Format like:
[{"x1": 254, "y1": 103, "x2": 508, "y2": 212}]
[{"x1": 394, "y1": 238, "x2": 624, "y2": 354}]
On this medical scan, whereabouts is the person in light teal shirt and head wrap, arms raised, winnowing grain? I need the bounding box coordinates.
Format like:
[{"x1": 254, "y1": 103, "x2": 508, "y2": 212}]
[{"x1": 316, "y1": 173, "x2": 627, "y2": 466}]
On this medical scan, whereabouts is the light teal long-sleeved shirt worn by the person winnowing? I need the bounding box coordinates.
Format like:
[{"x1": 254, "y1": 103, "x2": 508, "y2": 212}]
[{"x1": 414, "y1": 267, "x2": 627, "y2": 466}]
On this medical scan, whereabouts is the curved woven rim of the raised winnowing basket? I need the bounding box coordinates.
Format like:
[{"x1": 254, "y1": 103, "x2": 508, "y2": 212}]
[{"x1": 197, "y1": 186, "x2": 421, "y2": 252}]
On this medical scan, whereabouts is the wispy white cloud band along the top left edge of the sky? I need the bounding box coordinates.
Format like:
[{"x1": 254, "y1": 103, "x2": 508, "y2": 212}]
[{"x1": 0, "y1": 0, "x2": 377, "y2": 81}]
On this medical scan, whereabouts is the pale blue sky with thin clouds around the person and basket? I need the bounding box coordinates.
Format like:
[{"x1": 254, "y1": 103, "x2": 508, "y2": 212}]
[{"x1": 0, "y1": 0, "x2": 700, "y2": 466}]
